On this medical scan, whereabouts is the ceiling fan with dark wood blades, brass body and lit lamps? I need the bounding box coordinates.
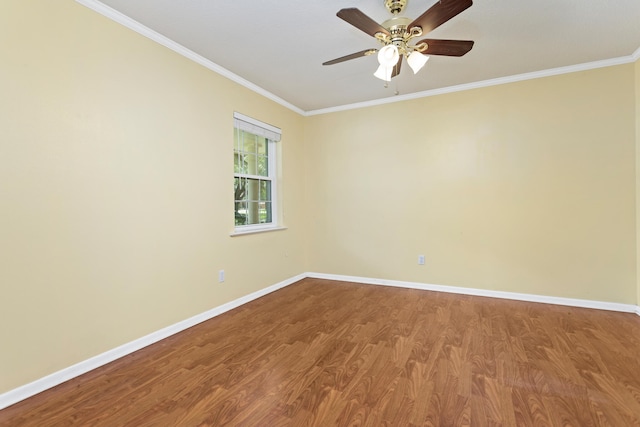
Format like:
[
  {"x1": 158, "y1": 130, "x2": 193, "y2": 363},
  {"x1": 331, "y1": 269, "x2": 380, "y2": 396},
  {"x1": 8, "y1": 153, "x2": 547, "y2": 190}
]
[{"x1": 322, "y1": 0, "x2": 473, "y2": 81}]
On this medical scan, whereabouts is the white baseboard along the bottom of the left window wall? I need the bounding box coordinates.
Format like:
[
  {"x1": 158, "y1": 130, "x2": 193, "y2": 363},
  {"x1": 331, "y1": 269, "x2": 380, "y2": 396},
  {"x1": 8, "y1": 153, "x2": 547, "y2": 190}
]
[{"x1": 0, "y1": 274, "x2": 306, "y2": 410}]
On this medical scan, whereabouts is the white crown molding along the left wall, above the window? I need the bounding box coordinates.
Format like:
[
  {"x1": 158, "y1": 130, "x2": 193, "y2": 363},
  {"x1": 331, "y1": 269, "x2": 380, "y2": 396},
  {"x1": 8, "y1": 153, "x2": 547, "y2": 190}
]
[{"x1": 76, "y1": 0, "x2": 305, "y2": 115}]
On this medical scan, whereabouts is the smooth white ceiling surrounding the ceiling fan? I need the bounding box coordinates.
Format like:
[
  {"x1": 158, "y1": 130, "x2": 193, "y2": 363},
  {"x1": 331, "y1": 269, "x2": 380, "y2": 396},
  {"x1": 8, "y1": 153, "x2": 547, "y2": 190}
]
[{"x1": 84, "y1": 0, "x2": 640, "y2": 112}]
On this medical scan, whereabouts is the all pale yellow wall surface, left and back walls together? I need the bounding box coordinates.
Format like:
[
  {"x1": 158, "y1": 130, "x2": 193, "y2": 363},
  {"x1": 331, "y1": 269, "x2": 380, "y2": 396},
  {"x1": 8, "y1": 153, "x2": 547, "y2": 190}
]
[{"x1": 0, "y1": 0, "x2": 640, "y2": 393}]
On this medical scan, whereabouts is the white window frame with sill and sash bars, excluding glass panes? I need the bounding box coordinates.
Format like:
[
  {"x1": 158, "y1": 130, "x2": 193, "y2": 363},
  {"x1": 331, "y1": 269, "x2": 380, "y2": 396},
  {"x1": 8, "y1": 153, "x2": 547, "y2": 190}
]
[{"x1": 231, "y1": 112, "x2": 284, "y2": 236}]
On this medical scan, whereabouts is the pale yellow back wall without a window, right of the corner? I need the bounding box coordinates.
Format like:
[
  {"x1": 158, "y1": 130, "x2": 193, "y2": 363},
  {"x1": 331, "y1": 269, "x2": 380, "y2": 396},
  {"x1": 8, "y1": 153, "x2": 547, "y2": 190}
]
[{"x1": 305, "y1": 64, "x2": 637, "y2": 304}]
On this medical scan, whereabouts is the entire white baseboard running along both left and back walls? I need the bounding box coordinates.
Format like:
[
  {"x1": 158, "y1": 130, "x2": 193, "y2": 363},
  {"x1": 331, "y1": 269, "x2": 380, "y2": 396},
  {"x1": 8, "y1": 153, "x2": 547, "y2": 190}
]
[{"x1": 0, "y1": 273, "x2": 640, "y2": 410}]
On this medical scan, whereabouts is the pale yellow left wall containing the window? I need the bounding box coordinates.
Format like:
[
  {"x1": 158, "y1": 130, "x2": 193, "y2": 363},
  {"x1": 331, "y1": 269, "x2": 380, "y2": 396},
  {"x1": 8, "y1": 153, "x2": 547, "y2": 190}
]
[{"x1": 0, "y1": 0, "x2": 305, "y2": 393}]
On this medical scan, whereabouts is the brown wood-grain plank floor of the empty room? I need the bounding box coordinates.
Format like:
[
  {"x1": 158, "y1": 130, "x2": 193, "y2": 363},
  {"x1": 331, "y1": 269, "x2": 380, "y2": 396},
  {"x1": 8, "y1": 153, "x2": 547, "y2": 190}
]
[{"x1": 0, "y1": 279, "x2": 640, "y2": 427}]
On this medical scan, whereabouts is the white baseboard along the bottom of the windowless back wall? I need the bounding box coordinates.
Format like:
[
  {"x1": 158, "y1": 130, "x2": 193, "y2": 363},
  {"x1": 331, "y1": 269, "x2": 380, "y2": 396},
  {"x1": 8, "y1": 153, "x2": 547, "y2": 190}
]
[{"x1": 306, "y1": 273, "x2": 640, "y2": 315}]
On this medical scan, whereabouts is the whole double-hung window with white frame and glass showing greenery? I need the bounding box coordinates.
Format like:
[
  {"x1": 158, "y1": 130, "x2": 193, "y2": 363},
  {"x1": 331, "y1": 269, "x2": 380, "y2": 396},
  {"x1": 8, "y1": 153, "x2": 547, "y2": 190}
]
[{"x1": 233, "y1": 113, "x2": 280, "y2": 233}]
